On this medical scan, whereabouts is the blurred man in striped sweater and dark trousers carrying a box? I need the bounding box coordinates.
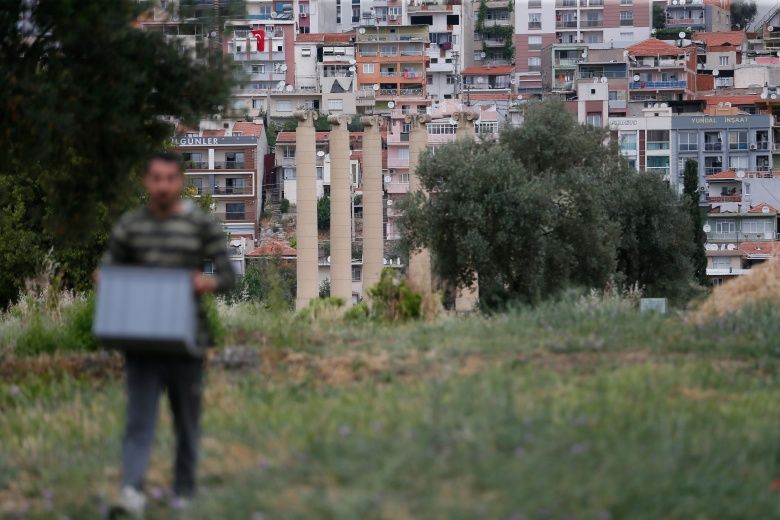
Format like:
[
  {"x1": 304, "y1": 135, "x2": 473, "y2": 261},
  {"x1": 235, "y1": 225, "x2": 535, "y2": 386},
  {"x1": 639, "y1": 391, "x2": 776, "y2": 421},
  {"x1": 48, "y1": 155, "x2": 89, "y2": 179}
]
[{"x1": 103, "y1": 153, "x2": 235, "y2": 517}]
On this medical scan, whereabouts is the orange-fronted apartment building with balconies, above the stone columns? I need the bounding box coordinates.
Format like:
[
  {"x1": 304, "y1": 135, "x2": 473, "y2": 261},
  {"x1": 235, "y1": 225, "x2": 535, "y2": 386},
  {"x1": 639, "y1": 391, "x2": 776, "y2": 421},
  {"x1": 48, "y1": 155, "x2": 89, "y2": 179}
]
[{"x1": 355, "y1": 25, "x2": 430, "y2": 113}]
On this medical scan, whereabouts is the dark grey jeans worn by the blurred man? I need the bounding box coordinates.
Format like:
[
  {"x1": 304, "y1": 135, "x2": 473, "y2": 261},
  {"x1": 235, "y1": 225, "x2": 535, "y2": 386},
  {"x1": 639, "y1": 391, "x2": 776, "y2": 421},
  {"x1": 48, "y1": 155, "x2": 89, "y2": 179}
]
[{"x1": 122, "y1": 354, "x2": 204, "y2": 496}]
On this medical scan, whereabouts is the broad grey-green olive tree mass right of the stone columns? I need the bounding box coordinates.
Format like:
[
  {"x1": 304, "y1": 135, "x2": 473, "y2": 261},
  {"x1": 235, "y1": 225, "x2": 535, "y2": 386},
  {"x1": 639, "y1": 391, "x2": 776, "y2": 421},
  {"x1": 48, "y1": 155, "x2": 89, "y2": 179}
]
[{"x1": 402, "y1": 100, "x2": 692, "y2": 308}]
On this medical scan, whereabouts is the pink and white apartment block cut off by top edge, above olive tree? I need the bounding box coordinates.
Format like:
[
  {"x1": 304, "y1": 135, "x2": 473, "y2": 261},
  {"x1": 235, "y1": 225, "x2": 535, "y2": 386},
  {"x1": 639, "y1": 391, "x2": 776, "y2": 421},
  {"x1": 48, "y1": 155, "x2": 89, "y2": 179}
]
[{"x1": 514, "y1": 0, "x2": 652, "y2": 93}]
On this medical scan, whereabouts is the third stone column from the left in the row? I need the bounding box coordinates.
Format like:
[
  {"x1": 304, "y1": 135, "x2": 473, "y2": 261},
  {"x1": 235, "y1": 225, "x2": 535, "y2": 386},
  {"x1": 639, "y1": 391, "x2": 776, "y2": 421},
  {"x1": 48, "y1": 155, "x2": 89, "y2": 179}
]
[{"x1": 361, "y1": 116, "x2": 385, "y2": 296}]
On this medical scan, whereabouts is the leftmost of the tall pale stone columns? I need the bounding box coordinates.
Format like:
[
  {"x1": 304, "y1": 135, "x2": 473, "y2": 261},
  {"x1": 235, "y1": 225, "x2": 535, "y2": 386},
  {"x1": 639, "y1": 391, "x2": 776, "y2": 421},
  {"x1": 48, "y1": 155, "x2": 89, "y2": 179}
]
[{"x1": 295, "y1": 110, "x2": 319, "y2": 309}]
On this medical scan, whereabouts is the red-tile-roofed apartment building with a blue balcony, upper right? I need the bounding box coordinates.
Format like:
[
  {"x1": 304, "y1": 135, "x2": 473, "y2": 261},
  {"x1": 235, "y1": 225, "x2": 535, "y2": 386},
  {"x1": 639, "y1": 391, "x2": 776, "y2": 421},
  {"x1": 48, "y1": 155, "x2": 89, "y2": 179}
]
[{"x1": 626, "y1": 38, "x2": 697, "y2": 113}]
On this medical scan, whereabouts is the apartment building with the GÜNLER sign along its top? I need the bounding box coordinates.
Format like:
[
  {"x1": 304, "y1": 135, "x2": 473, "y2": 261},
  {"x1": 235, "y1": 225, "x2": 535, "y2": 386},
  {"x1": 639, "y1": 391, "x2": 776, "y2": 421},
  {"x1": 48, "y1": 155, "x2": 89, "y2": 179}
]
[{"x1": 174, "y1": 122, "x2": 268, "y2": 240}]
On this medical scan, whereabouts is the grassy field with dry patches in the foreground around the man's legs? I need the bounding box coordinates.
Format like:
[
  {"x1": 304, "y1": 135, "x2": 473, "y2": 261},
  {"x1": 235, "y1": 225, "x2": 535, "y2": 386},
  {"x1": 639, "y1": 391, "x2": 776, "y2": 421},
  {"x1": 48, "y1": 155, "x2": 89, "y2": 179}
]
[{"x1": 0, "y1": 298, "x2": 780, "y2": 520}]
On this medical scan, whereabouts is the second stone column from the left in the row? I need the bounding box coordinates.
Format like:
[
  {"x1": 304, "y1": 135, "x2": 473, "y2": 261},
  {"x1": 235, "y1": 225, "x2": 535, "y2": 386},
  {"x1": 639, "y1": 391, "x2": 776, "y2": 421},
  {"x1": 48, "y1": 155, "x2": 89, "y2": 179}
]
[{"x1": 328, "y1": 116, "x2": 352, "y2": 306}]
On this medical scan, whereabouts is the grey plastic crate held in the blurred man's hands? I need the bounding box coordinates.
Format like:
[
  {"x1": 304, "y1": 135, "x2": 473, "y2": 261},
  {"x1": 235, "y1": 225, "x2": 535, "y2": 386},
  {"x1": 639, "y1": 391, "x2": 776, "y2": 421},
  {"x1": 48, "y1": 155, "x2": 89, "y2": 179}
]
[{"x1": 93, "y1": 266, "x2": 203, "y2": 356}]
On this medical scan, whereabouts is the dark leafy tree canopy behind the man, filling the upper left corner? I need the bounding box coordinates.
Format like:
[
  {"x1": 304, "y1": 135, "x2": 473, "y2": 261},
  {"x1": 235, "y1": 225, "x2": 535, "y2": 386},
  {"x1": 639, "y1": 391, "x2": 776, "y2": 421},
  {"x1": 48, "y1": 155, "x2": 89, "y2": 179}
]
[{"x1": 0, "y1": 0, "x2": 230, "y2": 307}]
